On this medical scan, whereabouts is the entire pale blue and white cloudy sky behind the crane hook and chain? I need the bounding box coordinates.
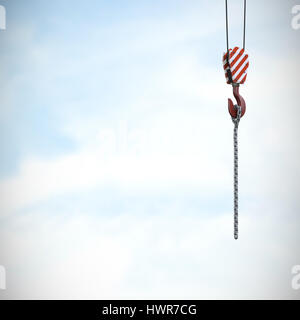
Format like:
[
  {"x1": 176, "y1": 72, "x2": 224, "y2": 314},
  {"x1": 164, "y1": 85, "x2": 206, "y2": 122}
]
[{"x1": 0, "y1": 0, "x2": 300, "y2": 299}]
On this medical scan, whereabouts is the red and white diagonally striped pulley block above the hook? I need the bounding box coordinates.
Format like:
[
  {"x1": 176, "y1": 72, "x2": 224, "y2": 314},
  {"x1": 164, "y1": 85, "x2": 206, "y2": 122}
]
[{"x1": 223, "y1": 47, "x2": 249, "y2": 84}]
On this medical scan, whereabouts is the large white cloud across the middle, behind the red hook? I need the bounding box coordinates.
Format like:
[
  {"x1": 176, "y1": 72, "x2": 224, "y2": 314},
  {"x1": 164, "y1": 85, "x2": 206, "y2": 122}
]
[{"x1": 0, "y1": 48, "x2": 298, "y2": 215}]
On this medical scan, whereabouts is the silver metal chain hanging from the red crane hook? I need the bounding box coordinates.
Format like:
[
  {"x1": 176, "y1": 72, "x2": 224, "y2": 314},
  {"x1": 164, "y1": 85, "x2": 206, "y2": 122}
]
[{"x1": 232, "y1": 105, "x2": 242, "y2": 240}]
